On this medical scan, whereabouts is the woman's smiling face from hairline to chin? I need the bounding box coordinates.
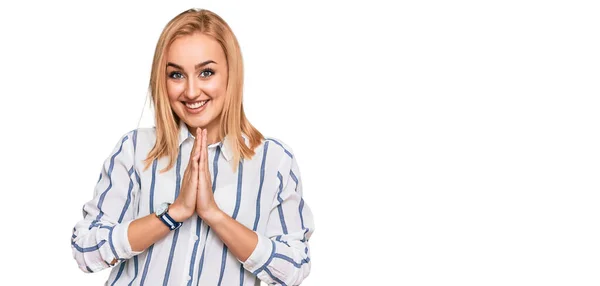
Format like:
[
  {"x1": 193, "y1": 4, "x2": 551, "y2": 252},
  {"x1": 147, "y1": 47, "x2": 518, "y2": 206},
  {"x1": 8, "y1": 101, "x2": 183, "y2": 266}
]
[{"x1": 166, "y1": 33, "x2": 227, "y2": 132}]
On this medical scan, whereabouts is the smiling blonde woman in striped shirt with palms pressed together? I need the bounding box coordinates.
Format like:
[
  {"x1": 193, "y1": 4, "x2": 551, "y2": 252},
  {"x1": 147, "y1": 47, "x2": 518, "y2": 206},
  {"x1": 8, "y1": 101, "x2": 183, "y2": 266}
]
[{"x1": 71, "y1": 9, "x2": 314, "y2": 285}]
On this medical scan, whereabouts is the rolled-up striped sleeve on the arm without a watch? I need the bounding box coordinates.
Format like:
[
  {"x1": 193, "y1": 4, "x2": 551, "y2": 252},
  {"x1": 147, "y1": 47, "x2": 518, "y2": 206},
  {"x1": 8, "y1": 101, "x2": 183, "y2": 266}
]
[{"x1": 242, "y1": 156, "x2": 315, "y2": 285}]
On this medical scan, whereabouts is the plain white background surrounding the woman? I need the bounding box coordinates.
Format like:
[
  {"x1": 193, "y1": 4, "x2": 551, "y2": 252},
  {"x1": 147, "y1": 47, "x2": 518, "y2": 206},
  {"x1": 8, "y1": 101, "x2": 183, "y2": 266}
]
[{"x1": 0, "y1": 1, "x2": 600, "y2": 286}]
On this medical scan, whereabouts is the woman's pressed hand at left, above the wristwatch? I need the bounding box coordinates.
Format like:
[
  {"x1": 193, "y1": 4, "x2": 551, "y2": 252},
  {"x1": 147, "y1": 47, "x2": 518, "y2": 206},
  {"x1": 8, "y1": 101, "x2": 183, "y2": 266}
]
[{"x1": 169, "y1": 128, "x2": 202, "y2": 222}]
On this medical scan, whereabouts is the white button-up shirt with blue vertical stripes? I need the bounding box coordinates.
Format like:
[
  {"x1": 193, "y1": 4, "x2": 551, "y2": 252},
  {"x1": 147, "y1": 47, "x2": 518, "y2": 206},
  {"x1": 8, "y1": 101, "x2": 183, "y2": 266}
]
[{"x1": 71, "y1": 119, "x2": 314, "y2": 286}]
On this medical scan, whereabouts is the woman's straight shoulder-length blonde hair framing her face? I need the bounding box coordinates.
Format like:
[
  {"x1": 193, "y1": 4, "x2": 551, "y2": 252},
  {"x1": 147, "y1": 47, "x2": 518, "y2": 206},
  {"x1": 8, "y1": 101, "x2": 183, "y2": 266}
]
[{"x1": 144, "y1": 9, "x2": 264, "y2": 173}]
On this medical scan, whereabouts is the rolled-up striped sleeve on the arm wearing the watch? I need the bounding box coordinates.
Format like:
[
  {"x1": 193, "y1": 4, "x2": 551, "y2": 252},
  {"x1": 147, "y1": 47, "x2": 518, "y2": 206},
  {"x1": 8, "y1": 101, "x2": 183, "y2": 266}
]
[{"x1": 71, "y1": 131, "x2": 140, "y2": 272}]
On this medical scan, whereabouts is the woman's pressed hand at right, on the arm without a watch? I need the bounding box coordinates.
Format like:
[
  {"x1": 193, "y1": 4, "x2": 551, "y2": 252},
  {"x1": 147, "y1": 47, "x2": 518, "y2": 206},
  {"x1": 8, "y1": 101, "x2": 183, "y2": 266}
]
[{"x1": 196, "y1": 128, "x2": 220, "y2": 220}]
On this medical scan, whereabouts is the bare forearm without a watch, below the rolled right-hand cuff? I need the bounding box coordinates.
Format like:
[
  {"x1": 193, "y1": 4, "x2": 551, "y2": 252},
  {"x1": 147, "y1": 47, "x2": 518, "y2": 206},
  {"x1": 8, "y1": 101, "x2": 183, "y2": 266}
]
[{"x1": 203, "y1": 210, "x2": 258, "y2": 261}]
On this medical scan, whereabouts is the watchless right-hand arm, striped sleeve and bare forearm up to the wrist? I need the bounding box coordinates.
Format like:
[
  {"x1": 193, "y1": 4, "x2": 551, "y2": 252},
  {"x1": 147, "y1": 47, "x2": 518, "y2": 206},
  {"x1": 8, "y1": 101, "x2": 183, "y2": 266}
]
[{"x1": 205, "y1": 153, "x2": 314, "y2": 285}]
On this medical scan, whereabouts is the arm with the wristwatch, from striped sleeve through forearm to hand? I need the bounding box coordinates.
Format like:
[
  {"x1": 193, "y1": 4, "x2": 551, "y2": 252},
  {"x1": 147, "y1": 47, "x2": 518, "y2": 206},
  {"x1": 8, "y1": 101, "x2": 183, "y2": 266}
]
[{"x1": 71, "y1": 131, "x2": 199, "y2": 272}]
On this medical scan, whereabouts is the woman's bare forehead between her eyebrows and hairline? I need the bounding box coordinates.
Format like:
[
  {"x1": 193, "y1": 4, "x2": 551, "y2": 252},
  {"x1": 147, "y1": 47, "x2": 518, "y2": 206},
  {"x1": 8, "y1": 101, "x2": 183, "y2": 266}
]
[{"x1": 167, "y1": 33, "x2": 225, "y2": 65}]
